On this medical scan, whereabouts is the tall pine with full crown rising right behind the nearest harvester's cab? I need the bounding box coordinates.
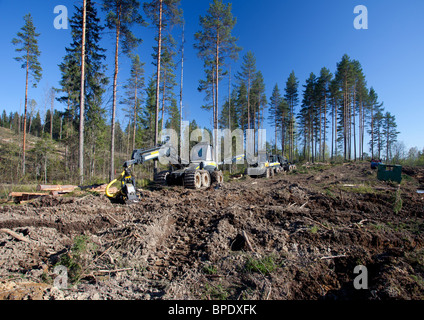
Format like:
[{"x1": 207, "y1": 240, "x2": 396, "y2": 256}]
[{"x1": 194, "y1": 0, "x2": 241, "y2": 160}]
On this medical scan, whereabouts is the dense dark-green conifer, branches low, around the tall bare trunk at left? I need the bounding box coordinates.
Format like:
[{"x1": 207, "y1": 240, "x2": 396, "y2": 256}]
[{"x1": 57, "y1": 0, "x2": 109, "y2": 183}]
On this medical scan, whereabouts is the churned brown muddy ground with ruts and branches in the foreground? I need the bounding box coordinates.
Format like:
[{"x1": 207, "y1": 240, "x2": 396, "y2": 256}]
[{"x1": 0, "y1": 163, "x2": 424, "y2": 300}]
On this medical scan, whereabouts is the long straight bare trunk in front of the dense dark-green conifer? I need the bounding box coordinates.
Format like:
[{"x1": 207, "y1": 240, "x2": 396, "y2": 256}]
[{"x1": 79, "y1": 0, "x2": 87, "y2": 185}]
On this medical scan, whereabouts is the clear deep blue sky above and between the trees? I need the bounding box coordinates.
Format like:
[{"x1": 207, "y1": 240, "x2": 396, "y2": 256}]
[{"x1": 0, "y1": 0, "x2": 424, "y2": 150}]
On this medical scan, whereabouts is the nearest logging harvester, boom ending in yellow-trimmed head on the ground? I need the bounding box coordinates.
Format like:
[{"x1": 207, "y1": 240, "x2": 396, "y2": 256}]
[{"x1": 106, "y1": 142, "x2": 224, "y2": 204}]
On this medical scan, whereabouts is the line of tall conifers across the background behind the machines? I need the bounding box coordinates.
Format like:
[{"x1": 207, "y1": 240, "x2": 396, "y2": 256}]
[{"x1": 0, "y1": 0, "x2": 418, "y2": 184}]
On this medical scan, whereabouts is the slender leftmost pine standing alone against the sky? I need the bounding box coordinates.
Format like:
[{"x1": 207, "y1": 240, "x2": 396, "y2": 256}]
[{"x1": 12, "y1": 13, "x2": 42, "y2": 175}]
